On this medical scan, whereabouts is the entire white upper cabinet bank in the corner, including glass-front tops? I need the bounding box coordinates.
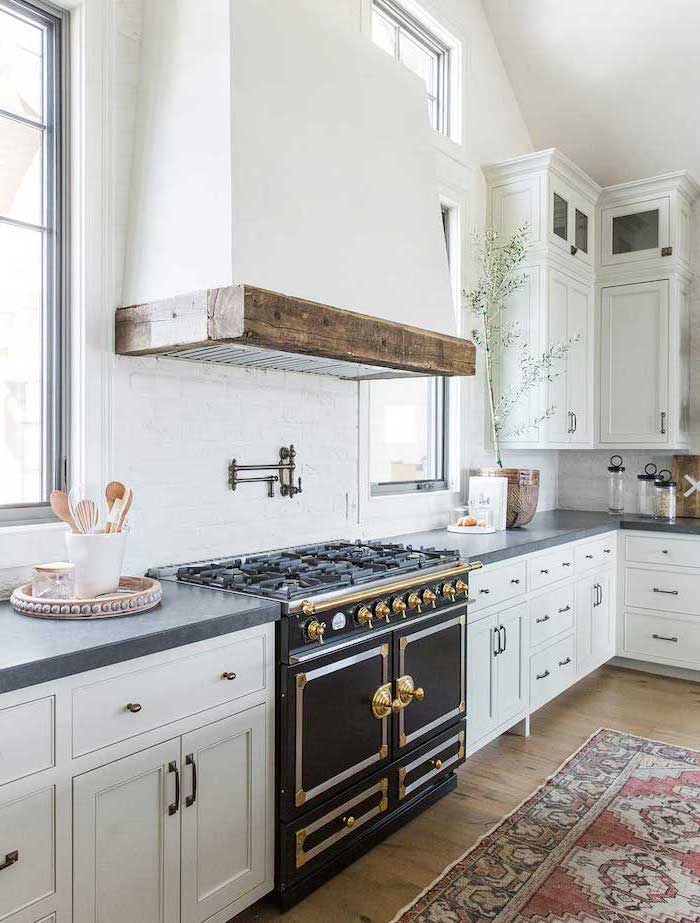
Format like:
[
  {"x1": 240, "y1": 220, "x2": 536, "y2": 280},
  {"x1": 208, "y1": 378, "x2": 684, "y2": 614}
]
[{"x1": 484, "y1": 150, "x2": 700, "y2": 450}]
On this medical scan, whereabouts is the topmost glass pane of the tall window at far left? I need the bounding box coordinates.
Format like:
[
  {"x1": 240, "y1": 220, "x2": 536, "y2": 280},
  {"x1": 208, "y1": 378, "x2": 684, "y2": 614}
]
[{"x1": 0, "y1": 10, "x2": 44, "y2": 121}]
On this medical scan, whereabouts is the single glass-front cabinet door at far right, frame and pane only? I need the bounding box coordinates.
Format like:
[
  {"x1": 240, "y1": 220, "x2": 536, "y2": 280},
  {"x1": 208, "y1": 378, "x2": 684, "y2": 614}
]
[{"x1": 601, "y1": 197, "x2": 671, "y2": 266}]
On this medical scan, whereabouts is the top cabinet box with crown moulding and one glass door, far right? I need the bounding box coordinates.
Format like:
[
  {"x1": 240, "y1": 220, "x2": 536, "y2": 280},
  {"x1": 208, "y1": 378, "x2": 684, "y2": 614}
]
[{"x1": 599, "y1": 171, "x2": 698, "y2": 271}]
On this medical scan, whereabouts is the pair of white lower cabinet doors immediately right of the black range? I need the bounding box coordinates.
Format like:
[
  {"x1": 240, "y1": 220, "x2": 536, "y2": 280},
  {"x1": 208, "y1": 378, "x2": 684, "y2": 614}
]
[{"x1": 467, "y1": 603, "x2": 527, "y2": 745}]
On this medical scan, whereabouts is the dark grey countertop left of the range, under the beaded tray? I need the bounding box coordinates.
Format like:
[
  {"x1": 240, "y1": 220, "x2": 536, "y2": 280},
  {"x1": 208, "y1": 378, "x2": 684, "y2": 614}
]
[{"x1": 0, "y1": 581, "x2": 280, "y2": 693}]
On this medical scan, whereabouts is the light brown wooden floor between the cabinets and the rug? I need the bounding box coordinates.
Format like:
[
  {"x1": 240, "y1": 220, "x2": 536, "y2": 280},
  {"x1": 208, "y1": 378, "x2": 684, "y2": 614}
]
[{"x1": 236, "y1": 667, "x2": 700, "y2": 923}]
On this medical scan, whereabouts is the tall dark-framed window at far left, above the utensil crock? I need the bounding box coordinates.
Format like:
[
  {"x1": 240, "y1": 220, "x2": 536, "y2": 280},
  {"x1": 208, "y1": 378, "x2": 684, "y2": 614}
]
[{"x1": 0, "y1": 0, "x2": 68, "y2": 520}]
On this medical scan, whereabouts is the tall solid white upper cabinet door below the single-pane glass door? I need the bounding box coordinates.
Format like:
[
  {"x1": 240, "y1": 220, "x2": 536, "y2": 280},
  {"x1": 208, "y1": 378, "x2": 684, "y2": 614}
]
[{"x1": 600, "y1": 279, "x2": 679, "y2": 447}]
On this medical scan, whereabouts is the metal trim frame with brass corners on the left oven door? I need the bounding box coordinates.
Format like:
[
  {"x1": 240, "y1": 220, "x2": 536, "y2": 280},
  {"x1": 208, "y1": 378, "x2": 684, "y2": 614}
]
[{"x1": 294, "y1": 642, "x2": 391, "y2": 808}]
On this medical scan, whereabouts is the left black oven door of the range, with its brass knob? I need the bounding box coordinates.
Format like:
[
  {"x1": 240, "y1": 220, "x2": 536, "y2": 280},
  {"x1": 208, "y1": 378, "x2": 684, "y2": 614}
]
[{"x1": 278, "y1": 637, "x2": 392, "y2": 819}]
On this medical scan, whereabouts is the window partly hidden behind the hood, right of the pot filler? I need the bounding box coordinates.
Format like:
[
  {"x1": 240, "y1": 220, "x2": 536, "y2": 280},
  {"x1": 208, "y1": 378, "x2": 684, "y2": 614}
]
[{"x1": 369, "y1": 207, "x2": 453, "y2": 495}]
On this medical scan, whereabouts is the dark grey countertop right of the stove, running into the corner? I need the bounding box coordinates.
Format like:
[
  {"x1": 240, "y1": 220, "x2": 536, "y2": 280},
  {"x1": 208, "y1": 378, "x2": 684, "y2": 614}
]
[{"x1": 387, "y1": 510, "x2": 700, "y2": 564}]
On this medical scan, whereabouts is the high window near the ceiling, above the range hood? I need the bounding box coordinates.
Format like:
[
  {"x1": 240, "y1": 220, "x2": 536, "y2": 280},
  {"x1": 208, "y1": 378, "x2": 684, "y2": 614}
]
[{"x1": 372, "y1": 0, "x2": 450, "y2": 134}]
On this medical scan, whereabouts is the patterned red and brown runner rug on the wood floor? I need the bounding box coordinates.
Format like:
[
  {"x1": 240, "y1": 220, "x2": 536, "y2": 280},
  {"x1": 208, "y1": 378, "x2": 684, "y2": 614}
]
[{"x1": 392, "y1": 729, "x2": 700, "y2": 923}]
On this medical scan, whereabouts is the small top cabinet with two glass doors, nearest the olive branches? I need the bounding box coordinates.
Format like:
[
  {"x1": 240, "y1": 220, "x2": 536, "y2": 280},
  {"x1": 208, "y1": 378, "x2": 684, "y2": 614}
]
[{"x1": 484, "y1": 150, "x2": 600, "y2": 272}]
